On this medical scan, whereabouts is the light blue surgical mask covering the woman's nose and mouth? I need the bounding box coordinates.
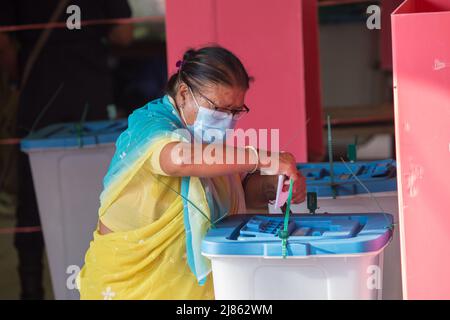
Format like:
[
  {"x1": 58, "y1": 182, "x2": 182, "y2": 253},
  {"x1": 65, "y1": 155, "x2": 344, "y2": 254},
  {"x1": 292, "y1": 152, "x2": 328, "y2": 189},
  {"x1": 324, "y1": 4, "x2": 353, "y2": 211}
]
[{"x1": 181, "y1": 88, "x2": 236, "y2": 143}]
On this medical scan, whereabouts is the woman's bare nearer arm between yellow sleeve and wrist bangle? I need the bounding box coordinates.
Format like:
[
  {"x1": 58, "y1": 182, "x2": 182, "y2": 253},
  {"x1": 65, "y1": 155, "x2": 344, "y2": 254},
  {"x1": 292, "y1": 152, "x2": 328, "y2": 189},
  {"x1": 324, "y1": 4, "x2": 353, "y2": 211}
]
[{"x1": 159, "y1": 142, "x2": 260, "y2": 177}]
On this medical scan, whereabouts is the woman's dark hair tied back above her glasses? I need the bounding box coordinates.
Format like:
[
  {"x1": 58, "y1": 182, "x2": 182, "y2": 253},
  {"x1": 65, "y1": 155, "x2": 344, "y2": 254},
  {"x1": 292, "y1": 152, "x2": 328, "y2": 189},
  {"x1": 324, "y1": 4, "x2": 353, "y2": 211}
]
[{"x1": 167, "y1": 46, "x2": 251, "y2": 97}]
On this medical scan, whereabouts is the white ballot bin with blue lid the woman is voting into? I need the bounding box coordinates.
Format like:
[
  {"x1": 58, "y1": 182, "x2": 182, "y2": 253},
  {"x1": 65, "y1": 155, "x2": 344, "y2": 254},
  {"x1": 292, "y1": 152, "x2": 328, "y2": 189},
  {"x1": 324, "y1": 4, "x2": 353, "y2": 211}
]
[{"x1": 202, "y1": 213, "x2": 393, "y2": 300}]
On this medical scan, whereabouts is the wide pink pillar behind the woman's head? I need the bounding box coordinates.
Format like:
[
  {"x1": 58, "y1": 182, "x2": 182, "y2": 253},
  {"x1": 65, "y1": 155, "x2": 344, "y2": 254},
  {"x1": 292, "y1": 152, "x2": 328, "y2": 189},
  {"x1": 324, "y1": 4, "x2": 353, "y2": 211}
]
[{"x1": 166, "y1": 0, "x2": 322, "y2": 161}]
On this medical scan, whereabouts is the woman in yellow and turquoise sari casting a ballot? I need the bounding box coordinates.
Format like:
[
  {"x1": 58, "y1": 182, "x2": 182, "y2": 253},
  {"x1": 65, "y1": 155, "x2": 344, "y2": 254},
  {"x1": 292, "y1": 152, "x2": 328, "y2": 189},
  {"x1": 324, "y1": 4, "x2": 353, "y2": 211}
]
[{"x1": 78, "y1": 47, "x2": 305, "y2": 299}]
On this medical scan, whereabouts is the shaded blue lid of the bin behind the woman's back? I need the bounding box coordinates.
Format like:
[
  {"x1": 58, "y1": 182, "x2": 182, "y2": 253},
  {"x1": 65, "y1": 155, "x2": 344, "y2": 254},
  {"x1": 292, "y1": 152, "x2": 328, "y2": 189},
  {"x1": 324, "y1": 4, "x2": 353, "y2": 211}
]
[{"x1": 21, "y1": 119, "x2": 127, "y2": 151}]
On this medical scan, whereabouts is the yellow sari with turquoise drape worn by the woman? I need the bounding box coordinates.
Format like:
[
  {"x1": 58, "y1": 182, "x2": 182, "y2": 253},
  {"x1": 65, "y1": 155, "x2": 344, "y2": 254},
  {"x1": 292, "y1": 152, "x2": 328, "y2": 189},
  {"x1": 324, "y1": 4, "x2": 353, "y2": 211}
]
[{"x1": 77, "y1": 96, "x2": 245, "y2": 299}]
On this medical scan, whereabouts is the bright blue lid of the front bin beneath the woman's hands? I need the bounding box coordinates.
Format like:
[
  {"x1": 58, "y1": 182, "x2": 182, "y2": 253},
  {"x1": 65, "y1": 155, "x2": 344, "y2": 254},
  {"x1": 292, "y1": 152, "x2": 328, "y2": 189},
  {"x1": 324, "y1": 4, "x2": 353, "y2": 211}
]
[{"x1": 202, "y1": 213, "x2": 393, "y2": 257}]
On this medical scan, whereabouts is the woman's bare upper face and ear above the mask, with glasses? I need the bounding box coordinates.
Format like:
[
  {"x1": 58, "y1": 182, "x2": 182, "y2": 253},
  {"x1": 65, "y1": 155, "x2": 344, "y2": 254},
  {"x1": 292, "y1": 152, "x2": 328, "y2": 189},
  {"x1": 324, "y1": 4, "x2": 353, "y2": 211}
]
[{"x1": 176, "y1": 84, "x2": 246, "y2": 125}]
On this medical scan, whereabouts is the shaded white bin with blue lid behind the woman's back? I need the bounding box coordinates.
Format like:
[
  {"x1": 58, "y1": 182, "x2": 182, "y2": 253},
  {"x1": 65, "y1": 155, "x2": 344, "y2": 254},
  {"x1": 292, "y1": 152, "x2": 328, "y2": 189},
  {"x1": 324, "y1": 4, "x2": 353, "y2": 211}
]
[{"x1": 21, "y1": 120, "x2": 127, "y2": 299}]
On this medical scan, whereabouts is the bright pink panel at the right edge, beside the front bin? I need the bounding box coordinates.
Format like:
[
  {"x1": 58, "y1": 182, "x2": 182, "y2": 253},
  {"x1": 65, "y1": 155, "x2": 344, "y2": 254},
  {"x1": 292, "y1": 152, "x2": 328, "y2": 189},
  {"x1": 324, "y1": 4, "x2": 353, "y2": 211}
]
[{"x1": 392, "y1": 0, "x2": 450, "y2": 299}]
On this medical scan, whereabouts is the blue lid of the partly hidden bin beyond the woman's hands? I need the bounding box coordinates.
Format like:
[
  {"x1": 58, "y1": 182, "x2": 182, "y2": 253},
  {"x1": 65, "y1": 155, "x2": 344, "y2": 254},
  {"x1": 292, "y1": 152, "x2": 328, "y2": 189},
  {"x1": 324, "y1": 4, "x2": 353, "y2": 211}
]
[{"x1": 297, "y1": 159, "x2": 397, "y2": 197}]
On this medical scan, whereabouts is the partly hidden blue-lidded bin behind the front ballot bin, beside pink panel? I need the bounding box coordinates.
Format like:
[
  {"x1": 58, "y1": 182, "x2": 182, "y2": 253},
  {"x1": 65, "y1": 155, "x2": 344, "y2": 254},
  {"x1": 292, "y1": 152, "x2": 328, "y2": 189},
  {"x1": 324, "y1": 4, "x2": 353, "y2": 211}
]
[{"x1": 269, "y1": 159, "x2": 402, "y2": 300}]
